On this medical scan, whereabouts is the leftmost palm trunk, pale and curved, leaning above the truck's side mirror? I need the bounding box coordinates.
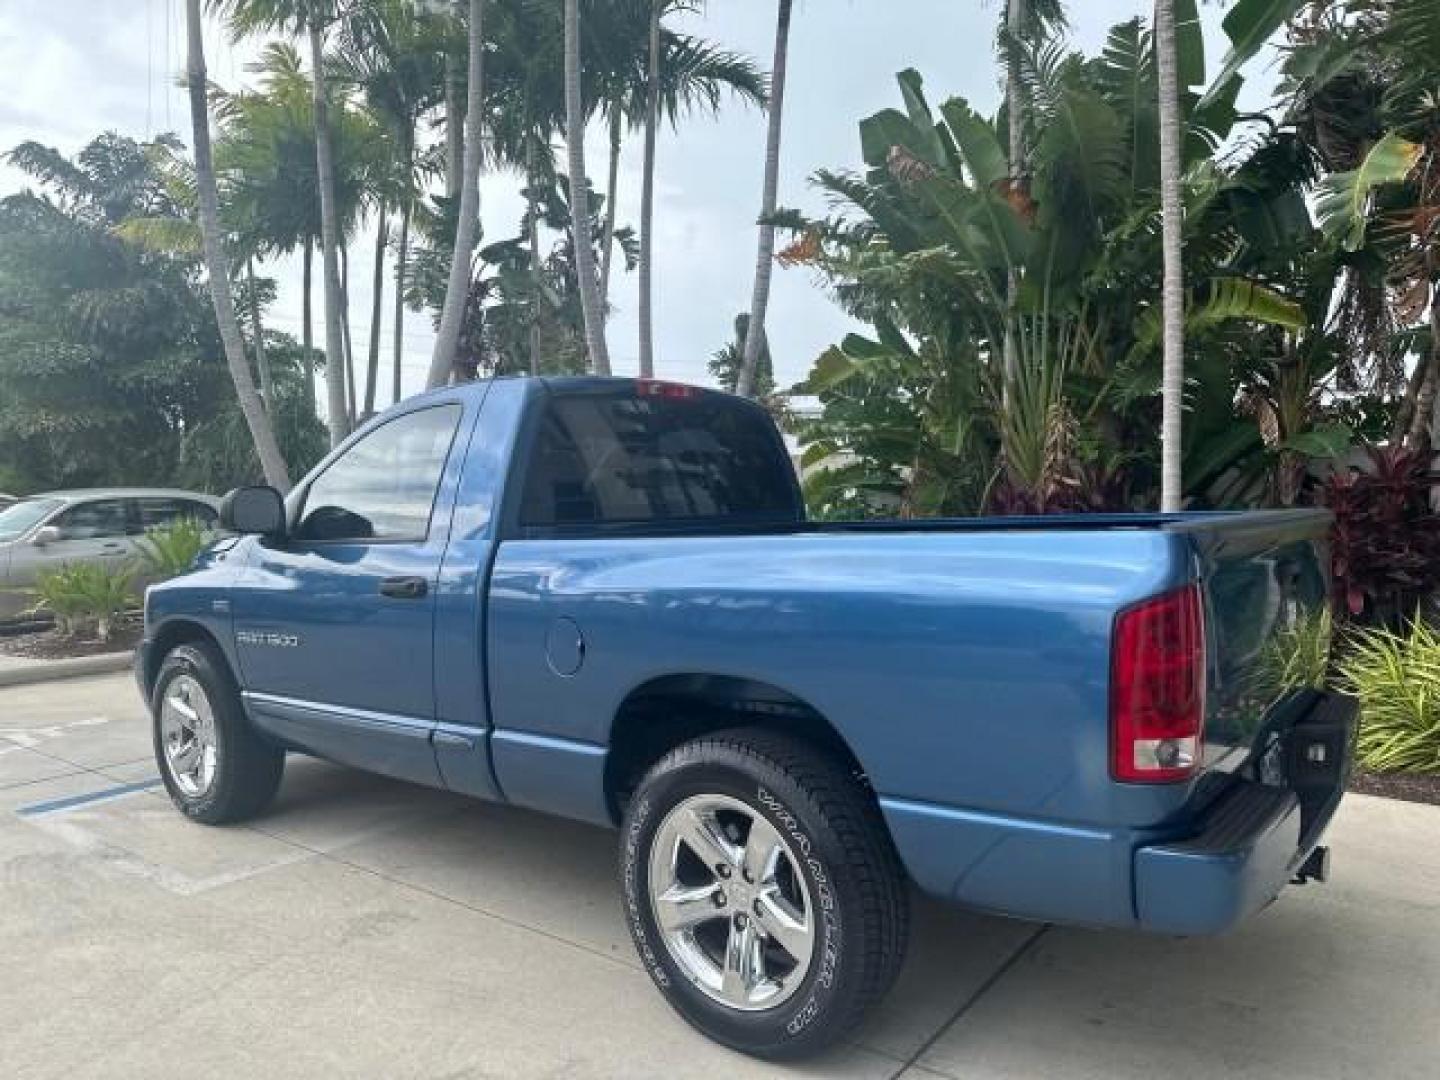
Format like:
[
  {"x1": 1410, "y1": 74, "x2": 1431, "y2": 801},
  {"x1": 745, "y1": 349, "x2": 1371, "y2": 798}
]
[{"x1": 186, "y1": 0, "x2": 289, "y2": 491}]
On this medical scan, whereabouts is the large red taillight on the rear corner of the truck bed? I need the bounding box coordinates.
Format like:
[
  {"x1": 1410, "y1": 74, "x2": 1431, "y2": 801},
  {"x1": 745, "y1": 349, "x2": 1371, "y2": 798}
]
[{"x1": 1110, "y1": 585, "x2": 1205, "y2": 783}]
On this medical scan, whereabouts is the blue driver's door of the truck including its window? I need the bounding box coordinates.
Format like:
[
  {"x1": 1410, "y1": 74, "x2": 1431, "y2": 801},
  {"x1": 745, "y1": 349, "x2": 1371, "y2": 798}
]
[{"x1": 233, "y1": 403, "x2": 464, "y2": 785}]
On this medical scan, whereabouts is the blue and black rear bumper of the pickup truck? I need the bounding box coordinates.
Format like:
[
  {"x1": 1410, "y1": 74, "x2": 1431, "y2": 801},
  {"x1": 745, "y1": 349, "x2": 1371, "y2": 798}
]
[{"x1": 1135, "y1": 694, "x2": 1356, "y2": 935}]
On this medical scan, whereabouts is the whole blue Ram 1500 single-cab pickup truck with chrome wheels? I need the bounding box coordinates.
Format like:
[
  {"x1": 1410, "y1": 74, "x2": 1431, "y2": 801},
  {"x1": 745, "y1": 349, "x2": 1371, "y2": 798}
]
[{"x1": 137, "y1": 379, "x2": 1355, "y2": 1057}]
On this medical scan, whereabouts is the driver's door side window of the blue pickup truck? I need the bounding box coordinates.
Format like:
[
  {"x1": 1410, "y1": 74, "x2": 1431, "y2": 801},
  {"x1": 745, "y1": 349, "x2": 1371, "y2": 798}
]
[{"x1": 295, "y1": 405, "x2": 464, "y2": 540}]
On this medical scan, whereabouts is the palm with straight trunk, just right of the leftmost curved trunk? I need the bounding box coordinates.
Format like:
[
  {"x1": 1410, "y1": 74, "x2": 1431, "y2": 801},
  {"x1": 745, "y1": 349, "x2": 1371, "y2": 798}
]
[{"x1": 215, "y1": 0, "x2": 350, "y2": 445}]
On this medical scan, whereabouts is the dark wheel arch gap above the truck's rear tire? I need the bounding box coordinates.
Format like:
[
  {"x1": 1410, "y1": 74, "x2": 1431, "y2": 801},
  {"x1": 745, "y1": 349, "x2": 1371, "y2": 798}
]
[{"x1": 605, "y1": 671, "x2": 874, "y2": 822}]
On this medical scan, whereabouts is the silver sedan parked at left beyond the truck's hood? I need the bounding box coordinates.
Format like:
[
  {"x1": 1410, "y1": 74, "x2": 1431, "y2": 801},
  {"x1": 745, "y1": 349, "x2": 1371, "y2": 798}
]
[{"x1": 0, "y1": 488, "x2": 220, "y2": 622}]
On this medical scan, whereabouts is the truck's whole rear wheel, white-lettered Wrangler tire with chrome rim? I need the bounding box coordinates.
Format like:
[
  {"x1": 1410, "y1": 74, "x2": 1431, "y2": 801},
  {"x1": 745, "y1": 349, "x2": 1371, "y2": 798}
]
[{"x1": 621, "y1": 729, "x2": 909, "y2": 1060}]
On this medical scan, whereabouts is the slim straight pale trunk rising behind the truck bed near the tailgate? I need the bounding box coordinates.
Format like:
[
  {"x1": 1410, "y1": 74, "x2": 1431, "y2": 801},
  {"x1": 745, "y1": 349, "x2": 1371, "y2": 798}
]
[{"x1": 1155, "y1": 0, "x2": 1185, "y2": 513}]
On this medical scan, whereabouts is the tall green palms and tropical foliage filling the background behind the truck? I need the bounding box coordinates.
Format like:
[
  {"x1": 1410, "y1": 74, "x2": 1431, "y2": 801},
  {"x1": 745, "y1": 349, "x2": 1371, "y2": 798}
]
[{"x1": 0, "y1": 0, "x2": 1440, "y2": 622}]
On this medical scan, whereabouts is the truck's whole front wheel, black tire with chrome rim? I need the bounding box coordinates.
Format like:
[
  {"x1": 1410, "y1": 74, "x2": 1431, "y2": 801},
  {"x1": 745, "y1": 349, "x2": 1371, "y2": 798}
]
[{"x1": 150, "y1": 642, "x2": 285, "y2": 825}]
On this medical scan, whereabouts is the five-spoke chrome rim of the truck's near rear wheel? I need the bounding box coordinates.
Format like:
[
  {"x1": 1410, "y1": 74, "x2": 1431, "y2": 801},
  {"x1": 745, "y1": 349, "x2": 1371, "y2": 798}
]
[{"x1": 649, "y1": 795, "x2": 815, "y2": 1012}]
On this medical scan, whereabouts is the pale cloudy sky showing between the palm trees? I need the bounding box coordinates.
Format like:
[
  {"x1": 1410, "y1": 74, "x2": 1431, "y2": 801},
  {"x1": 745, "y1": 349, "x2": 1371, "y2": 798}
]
[{"x1": 0, "y1": 0, "x2": 1284, "y2": 405}]
